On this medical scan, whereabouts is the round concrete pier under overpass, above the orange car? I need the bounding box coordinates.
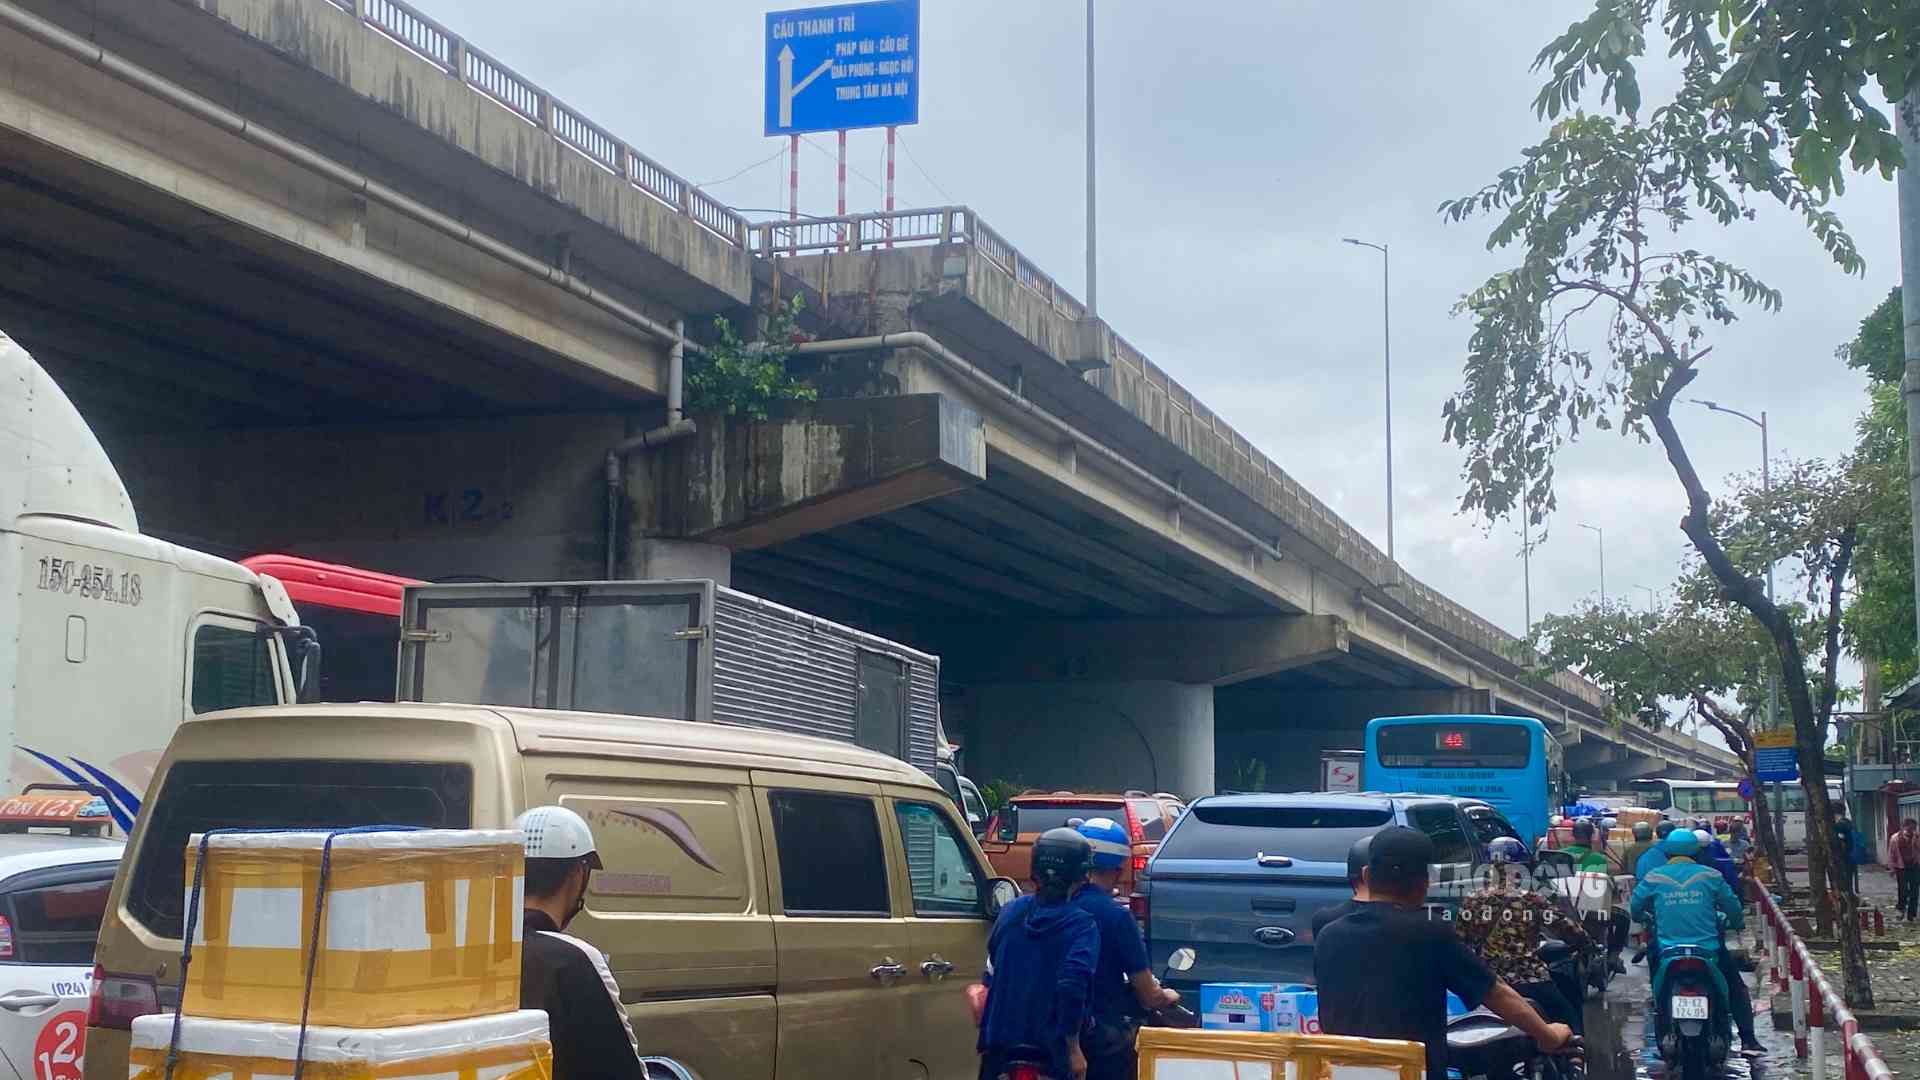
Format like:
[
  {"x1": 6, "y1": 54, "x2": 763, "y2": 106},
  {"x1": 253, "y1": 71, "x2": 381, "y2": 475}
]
[{"x1": 948, "y1": 680, "x2": 1213, "y2": 798}]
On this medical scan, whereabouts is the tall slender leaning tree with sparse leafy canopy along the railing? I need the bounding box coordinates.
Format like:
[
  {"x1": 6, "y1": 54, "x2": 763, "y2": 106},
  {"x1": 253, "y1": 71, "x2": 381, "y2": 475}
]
[{"x1": 1440, "y1": 0, "x2": 1889, "y2": 1007}]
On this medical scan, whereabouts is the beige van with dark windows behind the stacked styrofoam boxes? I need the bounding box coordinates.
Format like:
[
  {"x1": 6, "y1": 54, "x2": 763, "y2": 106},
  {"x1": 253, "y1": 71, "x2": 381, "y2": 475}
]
[{"x1": 86, "y1": 703, "x2": 1010, "y2": 1080}]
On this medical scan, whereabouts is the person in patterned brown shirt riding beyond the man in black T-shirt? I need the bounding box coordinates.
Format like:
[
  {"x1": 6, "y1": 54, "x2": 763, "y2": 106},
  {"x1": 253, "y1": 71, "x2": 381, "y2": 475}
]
[{"x1": 1453, "y1": 836, "x2": 1590, "y2": 1034}]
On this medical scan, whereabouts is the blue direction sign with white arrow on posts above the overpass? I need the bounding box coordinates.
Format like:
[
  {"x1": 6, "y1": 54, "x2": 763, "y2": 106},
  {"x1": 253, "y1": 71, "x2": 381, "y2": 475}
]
[{"x1": 766, "y1": 0, "x2": 920, "y2": 135}]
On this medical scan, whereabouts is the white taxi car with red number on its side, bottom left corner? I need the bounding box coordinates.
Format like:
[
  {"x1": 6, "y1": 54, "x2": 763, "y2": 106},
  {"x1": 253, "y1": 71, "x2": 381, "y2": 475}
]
[{"x1": 0, "y1": 832, "x2": 125, "y2": 1080}]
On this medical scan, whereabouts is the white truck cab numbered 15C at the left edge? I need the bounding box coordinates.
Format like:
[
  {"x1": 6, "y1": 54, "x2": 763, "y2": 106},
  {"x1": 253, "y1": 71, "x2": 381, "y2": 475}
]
[{"x1": 0, "y1": 332, "x2": 313, "y2": 830}]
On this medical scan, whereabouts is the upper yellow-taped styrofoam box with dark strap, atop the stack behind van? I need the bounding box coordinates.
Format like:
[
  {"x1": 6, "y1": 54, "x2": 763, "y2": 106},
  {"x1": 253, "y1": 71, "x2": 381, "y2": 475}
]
[{"x1": 182, "y1": 830, "x2": 526, "y2": 1028}]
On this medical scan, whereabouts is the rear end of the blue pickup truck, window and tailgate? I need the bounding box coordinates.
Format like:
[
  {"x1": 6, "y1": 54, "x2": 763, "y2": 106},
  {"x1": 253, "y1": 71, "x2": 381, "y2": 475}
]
[{"x1": 1142, "y1": 803, "x2": 1392, "y2": 988}]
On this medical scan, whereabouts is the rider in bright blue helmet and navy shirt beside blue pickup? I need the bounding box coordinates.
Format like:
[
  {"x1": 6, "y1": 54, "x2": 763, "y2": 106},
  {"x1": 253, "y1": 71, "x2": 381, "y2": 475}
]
[{"x1": 1073, "y1": 817, "x2": 1181, "y2": 1080}]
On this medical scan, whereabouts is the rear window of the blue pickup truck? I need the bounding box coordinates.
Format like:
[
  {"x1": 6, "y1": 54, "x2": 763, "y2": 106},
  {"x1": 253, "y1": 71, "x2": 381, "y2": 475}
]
[{"x1": 1144, "y1": 803, "x2": 1394, "y2": 863}]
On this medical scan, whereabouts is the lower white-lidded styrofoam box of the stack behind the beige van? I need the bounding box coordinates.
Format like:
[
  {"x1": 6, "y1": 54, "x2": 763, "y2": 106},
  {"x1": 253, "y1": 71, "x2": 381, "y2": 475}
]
[{"x1": 127, "y1": 1011, "x2": 553, "y2": 1080}]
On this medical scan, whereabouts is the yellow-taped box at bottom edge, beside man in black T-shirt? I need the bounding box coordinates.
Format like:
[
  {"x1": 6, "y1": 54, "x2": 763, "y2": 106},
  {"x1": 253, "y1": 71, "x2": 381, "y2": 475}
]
[{"x1": 1135, "y1": 1028, "x2": 1427, "y2": 1080}]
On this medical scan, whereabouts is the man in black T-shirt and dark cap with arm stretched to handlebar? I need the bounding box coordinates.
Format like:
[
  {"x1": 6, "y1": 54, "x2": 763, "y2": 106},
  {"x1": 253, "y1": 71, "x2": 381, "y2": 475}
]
[{"x1": 1313, "y1": 826, "x2": 1572, "y2": 1080}]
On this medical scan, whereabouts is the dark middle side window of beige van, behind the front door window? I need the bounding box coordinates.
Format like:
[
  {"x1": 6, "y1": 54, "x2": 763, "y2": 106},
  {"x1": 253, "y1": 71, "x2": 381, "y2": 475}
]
[{"x1": 768, "y1": 792, "x2": 893, "y2": 917}]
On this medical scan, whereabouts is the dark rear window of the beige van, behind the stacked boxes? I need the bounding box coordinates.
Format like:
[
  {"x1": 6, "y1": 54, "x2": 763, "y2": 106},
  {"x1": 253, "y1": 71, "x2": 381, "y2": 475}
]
[{"x1": 125, "y1": 761, "x2": 474, "y2": 938}]
